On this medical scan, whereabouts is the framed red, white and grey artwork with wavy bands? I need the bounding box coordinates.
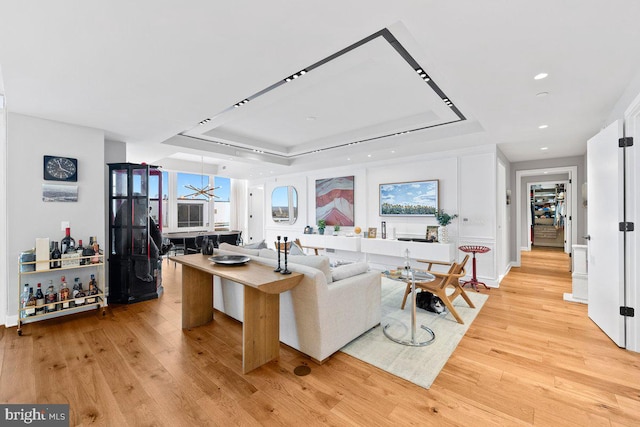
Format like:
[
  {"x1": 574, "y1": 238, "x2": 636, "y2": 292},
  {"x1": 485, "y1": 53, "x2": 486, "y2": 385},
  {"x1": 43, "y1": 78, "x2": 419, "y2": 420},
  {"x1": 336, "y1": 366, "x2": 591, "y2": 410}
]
[{"x1": 316, "y1": 176, "x2": 354, "y2": 226}]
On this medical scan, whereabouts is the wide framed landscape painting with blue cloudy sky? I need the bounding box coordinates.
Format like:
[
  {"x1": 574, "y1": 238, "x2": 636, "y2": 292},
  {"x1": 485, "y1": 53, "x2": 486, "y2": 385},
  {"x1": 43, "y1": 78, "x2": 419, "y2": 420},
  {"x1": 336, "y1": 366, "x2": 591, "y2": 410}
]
[{"x1": 380, "y1": 179, "x2": 438, "y2": 216}]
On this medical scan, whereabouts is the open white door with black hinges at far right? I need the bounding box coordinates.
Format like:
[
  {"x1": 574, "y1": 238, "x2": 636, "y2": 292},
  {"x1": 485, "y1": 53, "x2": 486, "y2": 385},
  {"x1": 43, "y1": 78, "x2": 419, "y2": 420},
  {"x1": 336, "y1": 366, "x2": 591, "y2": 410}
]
[{"x1": 587, "y1": 121, "x2": 625, "y2": 347}]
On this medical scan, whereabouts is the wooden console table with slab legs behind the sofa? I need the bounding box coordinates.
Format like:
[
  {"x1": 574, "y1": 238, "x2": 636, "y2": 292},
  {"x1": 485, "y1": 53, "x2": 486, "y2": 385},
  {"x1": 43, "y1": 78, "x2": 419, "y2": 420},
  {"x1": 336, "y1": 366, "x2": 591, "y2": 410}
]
[{"x1": 170, "y1": 254, "x2": 304, "y2": 374}]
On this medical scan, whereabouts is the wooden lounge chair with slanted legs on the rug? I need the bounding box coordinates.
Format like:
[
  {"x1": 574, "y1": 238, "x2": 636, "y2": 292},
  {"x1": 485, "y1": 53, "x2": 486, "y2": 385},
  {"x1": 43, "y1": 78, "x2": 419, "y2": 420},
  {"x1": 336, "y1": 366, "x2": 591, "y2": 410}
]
[{"x1": 400, "y1": 255, "x2": 476, "y2": 325}]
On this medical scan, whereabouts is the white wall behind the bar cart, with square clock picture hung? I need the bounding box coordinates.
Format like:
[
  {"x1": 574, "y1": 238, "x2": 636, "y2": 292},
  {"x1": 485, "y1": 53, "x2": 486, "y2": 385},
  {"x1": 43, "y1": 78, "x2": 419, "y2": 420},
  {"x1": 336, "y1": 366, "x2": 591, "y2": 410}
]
[{"x1": 5, "y1": 113, "x2": 106, "y2": 326}]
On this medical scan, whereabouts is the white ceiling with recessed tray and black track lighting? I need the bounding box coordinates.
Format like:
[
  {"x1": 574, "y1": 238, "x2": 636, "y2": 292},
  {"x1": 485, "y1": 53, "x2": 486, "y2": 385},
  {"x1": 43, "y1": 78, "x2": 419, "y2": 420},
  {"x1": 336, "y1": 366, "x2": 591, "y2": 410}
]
[{"x1": 0, "y1": 0, "x2": 640, "y2": 178}]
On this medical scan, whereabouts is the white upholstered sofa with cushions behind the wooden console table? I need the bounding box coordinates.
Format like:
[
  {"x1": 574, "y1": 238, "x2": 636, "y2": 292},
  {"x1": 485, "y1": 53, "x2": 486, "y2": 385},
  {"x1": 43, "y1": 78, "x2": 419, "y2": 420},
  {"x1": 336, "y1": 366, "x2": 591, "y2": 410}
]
[{"x1": 214, "y1": 244, "x2": 381, "y2": 363}]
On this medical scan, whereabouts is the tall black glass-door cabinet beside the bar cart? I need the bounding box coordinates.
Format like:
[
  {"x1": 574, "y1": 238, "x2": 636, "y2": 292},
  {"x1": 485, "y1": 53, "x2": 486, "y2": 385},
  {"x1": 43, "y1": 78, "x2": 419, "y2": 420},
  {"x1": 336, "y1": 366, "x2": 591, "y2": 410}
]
[{"x1": 108, "y1": 163, "x2": 162, "y2": 304}]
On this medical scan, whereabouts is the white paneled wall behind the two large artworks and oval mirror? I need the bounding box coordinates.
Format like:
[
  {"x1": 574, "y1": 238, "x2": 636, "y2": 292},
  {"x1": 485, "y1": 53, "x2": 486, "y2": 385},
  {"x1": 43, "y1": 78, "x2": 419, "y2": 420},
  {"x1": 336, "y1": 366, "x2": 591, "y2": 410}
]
[{"x1": 254, "y1": 145, "x2": 498, "y2": 285}]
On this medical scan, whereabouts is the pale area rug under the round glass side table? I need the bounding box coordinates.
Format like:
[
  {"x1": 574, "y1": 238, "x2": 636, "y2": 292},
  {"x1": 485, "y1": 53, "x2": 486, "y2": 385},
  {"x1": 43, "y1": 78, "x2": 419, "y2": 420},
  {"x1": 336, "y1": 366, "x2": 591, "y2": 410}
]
[{"x1": 341, "y1": 278, "x2": 488, "y2": 388}]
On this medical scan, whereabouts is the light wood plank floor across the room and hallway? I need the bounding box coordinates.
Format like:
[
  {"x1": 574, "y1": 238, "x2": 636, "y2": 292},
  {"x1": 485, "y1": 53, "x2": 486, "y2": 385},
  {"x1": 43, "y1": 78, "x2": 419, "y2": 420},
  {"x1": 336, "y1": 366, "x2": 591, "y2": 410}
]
[{"x1": 0, "y1": 249, "x2": 640, "y2": 426}]
